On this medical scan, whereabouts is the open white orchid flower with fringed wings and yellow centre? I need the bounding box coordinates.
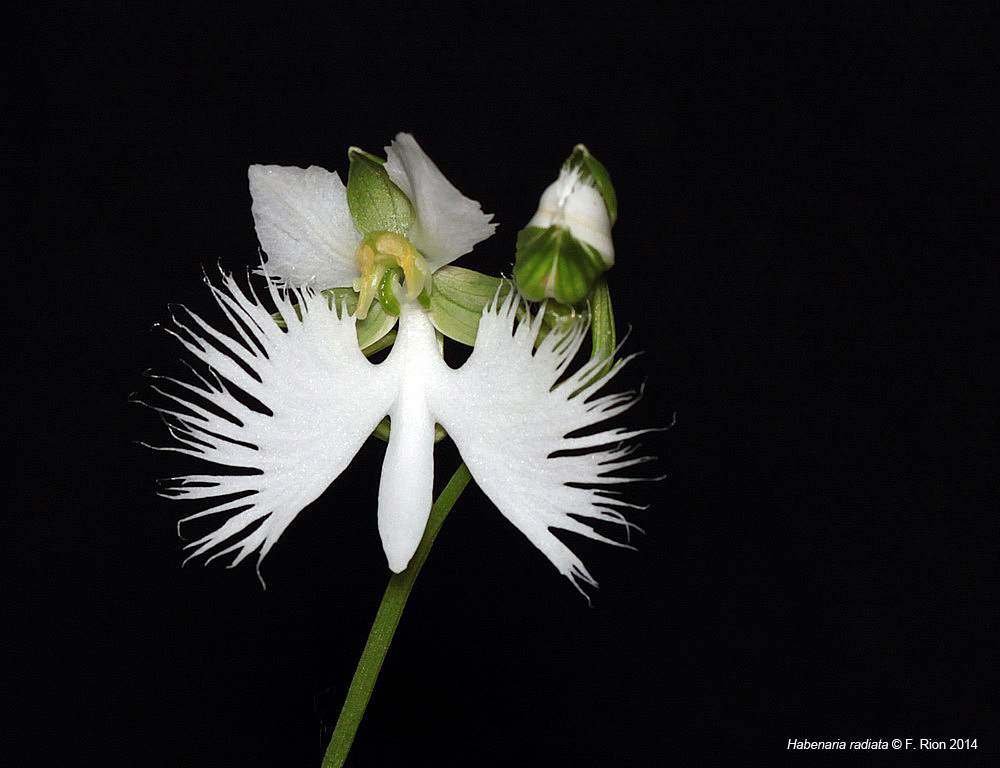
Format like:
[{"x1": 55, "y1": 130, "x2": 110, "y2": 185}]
[{"x1": 152, "y1": 133, "x2": 642, "y2": 589}]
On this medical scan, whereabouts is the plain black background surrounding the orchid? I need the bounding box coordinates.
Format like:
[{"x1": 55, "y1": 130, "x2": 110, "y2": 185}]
[{"x1": 11, "y1": 2, "x2": 998, "y2": 766}]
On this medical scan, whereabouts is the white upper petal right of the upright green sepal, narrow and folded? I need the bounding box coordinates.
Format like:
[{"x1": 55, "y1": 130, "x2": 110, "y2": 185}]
[{"x1": 385, "y1": 133, "x2": 497, "y2": 271}]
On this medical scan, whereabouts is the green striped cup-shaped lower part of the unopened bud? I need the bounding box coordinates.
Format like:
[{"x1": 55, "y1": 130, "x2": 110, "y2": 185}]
[{"x1": 514, "y1": 225, "x2": 607, "y2": 304}]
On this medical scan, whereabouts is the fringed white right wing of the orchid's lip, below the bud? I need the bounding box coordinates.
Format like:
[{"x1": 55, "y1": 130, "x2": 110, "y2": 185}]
[{"x1": 431, "y1": 292, "x2": 647, "y2": 592}]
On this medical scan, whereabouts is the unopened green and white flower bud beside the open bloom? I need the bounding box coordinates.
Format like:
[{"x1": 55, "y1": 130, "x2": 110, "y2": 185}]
[{"x1": 514, "y1": 144, "x2": 617, "y2": 304}]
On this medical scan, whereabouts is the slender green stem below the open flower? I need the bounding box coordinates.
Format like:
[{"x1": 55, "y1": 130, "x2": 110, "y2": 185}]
[{"x1": 322, "y1": 464, "x2": 472, "y2": 768}]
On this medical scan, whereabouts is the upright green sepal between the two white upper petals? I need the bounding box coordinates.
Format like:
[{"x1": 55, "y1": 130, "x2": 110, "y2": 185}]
[{"x1": 347, "y1": 147, "x2": 416, "y2": 236}]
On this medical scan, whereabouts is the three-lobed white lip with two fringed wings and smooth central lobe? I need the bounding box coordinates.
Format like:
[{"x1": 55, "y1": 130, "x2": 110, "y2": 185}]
[{"x1": 148, "y1": 276, "x2": 646, "y2": 591}]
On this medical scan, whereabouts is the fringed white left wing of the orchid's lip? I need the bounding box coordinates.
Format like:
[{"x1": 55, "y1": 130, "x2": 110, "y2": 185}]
[{"x1": 156, "y1": 276, "x2": 398, "y2": 565}]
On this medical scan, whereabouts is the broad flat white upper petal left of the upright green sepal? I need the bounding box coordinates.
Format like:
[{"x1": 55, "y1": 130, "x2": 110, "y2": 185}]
[{"x1": 247, "y1": 165, "x2": 361, "y2": 290}]
